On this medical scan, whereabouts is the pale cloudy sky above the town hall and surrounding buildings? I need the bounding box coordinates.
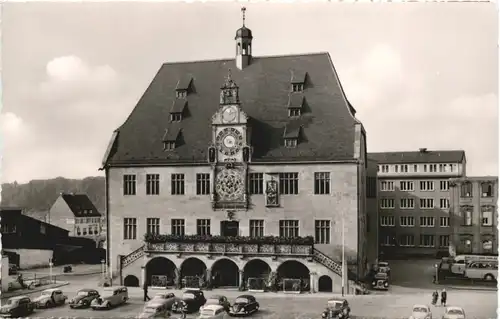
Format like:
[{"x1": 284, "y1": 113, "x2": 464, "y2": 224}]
[{"x1": 0, "y1": 2, "x2": 499, "y2": 183}]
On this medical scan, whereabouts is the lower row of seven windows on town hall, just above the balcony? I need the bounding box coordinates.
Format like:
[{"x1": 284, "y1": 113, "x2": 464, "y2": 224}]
[{"x1": 123, "y1": 217, "x2": 331, "y2": 244}]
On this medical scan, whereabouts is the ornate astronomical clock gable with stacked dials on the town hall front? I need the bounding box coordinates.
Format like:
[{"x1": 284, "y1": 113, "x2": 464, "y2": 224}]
[{"x1": 208, "y1": 70, "x2": 251, "y2": 210}]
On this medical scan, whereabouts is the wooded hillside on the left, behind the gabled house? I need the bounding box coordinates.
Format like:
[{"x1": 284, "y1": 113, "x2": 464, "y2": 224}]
[{"x1": 1, "y1": 176, "x2": 105, "y2": 217}]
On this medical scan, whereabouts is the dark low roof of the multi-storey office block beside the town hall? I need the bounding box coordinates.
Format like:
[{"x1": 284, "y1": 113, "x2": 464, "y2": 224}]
[{"x1": 368, "y1": 150, "x2": 465, "y2": 164}]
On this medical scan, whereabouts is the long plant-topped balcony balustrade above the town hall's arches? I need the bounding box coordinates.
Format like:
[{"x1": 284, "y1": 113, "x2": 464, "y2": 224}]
[{"x1": 145, "y1": 235, "x2": 313, "y2": 257}]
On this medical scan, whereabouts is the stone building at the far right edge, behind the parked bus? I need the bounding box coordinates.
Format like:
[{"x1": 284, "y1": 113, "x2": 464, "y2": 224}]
[{"x1": 450, "y1": 176, "x2": 498, "y2": 254}]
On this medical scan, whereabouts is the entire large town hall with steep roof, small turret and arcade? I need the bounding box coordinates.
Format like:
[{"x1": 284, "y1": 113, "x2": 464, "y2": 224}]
[{"x1": 102, "y1": 11, "x2": 378, "y2": 292}]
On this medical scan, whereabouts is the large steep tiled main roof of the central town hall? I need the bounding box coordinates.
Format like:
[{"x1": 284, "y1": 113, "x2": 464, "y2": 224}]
[{"x1": 107, "y1": 53, "x2": 359, "y2": 165}]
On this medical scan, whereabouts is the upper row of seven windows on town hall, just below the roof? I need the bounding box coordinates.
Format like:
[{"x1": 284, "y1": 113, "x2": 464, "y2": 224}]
[{"x1": 123, "y1": 172, "x2": 352, "y2": 195}]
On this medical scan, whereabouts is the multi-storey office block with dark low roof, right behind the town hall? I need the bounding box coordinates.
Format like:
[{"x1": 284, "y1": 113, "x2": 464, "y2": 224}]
[{"x1": 368, "y1": 148, "x2": 466, "y2": 258}]
